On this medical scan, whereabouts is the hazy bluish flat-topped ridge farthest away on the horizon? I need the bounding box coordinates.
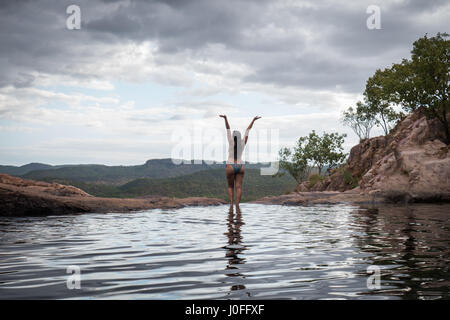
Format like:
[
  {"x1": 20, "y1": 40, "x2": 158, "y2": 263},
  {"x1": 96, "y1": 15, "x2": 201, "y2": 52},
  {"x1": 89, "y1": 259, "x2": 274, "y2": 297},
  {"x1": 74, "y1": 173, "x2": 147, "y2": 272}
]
[{"x1": 19, "y1": 159, "x2": 272, "y2": 185}]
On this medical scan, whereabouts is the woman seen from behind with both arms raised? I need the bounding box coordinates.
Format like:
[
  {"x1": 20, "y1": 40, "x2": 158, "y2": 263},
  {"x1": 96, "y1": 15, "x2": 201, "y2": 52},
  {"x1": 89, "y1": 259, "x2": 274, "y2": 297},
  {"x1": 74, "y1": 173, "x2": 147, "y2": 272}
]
[{"x1": 220, "y1": 115, "x2": 261, "y2": 213}]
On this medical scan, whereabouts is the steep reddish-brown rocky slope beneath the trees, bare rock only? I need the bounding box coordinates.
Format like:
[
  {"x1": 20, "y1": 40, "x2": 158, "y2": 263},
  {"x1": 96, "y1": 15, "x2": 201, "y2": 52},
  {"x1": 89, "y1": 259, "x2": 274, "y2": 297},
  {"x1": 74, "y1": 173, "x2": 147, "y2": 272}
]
[{"x1": 296, "y1": 110, "x2": 450, "y2": 202}]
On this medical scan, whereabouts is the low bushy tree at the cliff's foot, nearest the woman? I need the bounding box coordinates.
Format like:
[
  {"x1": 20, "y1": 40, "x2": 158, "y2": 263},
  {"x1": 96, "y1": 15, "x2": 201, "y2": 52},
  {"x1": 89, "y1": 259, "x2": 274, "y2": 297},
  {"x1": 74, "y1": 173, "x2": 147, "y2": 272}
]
[{"x1": 279, "y1": 130, "x2": 346, "y2": 183}]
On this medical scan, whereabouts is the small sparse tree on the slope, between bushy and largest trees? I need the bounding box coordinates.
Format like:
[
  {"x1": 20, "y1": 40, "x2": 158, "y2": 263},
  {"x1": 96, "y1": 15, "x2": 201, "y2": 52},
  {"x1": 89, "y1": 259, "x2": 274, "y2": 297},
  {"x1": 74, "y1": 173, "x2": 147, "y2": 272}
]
[{"x1": 342, "y1": 101, "x2": 376, "y2": 141}]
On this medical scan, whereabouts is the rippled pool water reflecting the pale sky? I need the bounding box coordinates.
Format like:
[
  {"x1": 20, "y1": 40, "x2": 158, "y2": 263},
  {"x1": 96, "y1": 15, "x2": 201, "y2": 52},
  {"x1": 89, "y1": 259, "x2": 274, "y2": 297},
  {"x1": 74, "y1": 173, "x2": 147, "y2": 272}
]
[{"x1": 0, "y1": 204, "x2": 450, "y2": 299}]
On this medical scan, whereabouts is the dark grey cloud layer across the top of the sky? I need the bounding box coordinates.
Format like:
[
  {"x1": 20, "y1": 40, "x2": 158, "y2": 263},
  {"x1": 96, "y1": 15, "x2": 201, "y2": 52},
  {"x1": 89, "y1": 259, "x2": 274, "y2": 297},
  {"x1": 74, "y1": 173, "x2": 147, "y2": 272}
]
[{"x1": 0, "y1": 0, "x2": 449, "y2": 92}]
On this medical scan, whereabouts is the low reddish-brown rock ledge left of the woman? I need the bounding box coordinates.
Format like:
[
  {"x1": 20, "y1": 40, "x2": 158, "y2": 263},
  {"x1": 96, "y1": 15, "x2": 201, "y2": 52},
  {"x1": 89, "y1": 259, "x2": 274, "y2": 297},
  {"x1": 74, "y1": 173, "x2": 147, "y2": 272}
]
[{"x1": 0, "y1": 174, "x2": 227, "y2": 216}]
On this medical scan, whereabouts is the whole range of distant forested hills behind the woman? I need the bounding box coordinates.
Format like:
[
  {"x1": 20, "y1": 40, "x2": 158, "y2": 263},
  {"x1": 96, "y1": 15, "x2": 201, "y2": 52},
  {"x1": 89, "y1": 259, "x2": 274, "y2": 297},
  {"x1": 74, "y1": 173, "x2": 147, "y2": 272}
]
[{"x1": 0, "y1": 159, "x2": 288, "y2": 200}]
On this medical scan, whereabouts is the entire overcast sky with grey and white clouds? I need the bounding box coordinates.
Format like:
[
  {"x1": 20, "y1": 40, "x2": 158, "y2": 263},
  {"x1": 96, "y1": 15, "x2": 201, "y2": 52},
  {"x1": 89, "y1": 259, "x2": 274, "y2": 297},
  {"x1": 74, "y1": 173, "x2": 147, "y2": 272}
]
[{"x1": 0, "y1": 0, "x2": 450, "y2": 165}]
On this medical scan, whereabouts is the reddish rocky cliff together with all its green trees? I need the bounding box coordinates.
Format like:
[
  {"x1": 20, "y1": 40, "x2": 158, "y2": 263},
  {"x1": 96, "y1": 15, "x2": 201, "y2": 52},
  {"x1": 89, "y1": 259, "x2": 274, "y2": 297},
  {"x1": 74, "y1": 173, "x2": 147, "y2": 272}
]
[{"x1": 280, "y1": 33, "x2": 450, "y2": 199}]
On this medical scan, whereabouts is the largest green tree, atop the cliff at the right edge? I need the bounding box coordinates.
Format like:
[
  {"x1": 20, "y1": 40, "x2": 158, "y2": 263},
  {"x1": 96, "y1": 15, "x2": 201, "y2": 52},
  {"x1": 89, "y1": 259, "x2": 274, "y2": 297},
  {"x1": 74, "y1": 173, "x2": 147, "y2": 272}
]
[{"x1": 364, "y1": 33, "x2": 450, "y2": 144}]
